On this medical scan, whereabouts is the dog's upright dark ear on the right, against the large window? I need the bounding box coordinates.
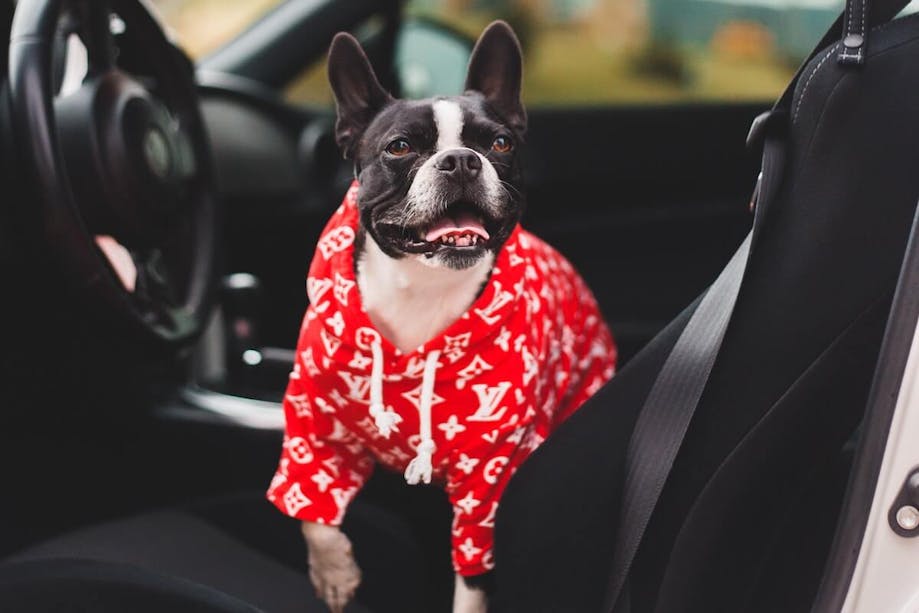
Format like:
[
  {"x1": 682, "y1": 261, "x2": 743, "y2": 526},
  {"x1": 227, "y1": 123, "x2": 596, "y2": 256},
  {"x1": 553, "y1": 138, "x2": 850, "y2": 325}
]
[{"x1": 466, "y1": 21, "x2": 527, "y2": 134}]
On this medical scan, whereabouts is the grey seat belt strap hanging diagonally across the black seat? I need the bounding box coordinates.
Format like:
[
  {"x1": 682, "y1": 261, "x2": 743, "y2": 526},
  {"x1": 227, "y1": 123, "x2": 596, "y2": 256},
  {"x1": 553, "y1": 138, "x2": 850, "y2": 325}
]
[{"x1": 603, "y1": 0, "x2": 907, "y2": 613}]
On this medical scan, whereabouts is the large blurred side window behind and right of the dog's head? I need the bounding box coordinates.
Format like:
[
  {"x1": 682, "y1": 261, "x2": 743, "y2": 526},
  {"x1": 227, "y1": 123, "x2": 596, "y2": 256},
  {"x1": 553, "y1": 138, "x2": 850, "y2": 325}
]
[{"x1": 406, "y1": 0, "x2": 843, "y2": 106}]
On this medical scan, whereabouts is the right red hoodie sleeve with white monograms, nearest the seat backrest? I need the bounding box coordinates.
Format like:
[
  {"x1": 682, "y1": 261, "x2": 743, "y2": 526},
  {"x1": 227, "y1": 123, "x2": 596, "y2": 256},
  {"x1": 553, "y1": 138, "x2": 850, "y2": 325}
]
[{"x1": 447, "y1": 428, "x2": 528, "y2": 577}]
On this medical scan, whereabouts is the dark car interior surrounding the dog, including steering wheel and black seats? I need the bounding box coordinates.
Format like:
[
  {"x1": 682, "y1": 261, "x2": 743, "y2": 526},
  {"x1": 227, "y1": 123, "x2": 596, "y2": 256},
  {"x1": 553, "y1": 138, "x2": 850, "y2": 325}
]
[{"x1": 0, "y1": 0, "x2": 919, "y2": 613}]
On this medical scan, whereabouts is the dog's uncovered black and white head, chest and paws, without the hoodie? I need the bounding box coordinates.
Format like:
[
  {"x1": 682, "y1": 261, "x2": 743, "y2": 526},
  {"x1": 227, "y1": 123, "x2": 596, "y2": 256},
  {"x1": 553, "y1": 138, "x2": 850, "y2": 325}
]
[{"x1": 303, "y1": 22, "x2": 527, "y2": 613}]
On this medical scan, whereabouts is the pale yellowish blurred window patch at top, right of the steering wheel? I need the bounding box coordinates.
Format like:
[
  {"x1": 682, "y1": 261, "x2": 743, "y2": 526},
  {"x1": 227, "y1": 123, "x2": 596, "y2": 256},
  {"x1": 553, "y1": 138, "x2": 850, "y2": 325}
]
[{"x1": 150, "y1": 0, "x2": 285, "y2": 59}]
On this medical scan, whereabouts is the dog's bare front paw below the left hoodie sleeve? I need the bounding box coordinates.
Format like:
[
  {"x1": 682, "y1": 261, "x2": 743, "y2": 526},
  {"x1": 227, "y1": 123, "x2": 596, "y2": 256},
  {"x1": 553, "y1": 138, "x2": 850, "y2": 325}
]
[{"x1": 301, "y1": 521, "x2": 361, "y2": 613}]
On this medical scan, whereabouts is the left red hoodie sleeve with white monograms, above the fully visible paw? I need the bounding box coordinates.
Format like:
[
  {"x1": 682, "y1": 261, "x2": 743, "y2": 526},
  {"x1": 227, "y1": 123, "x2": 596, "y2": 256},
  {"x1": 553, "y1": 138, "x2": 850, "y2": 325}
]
[{"x1": 267, "y1": 316, "x2": 374, "y2": 526}]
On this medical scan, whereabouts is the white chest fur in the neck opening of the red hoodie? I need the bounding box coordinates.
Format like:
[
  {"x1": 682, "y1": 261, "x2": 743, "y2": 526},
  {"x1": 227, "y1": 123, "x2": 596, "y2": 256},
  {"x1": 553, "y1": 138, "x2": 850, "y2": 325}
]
[{"x1": 357, "y1": 236, "x2": 494, "y2": 353}]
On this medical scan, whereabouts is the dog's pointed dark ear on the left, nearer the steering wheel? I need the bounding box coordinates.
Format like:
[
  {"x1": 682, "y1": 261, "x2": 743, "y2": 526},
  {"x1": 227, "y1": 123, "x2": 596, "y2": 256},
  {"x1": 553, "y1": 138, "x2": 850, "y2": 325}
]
[{"x1": 329, "y1": 32, "x2": 393, "y2": 158}]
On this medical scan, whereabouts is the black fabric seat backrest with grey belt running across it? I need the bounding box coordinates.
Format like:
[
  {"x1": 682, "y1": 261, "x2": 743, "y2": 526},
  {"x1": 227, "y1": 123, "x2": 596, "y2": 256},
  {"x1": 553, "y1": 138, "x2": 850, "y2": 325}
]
[{"x1": 495, "y1": 11, "x2": 919, "y2": 613}]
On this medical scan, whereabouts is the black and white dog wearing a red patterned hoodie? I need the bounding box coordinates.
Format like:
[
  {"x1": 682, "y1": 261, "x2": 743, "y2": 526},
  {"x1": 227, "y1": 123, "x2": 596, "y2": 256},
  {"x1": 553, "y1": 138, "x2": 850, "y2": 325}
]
[{"x1": 268, "y1": 22, "x2": 616, "y2": 613}]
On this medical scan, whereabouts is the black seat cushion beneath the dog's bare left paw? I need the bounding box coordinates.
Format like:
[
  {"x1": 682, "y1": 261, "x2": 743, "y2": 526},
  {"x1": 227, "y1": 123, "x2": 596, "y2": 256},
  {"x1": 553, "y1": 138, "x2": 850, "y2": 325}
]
[{"x1": 0, "y1": 492, "x2": 440, "y2": 613}]
